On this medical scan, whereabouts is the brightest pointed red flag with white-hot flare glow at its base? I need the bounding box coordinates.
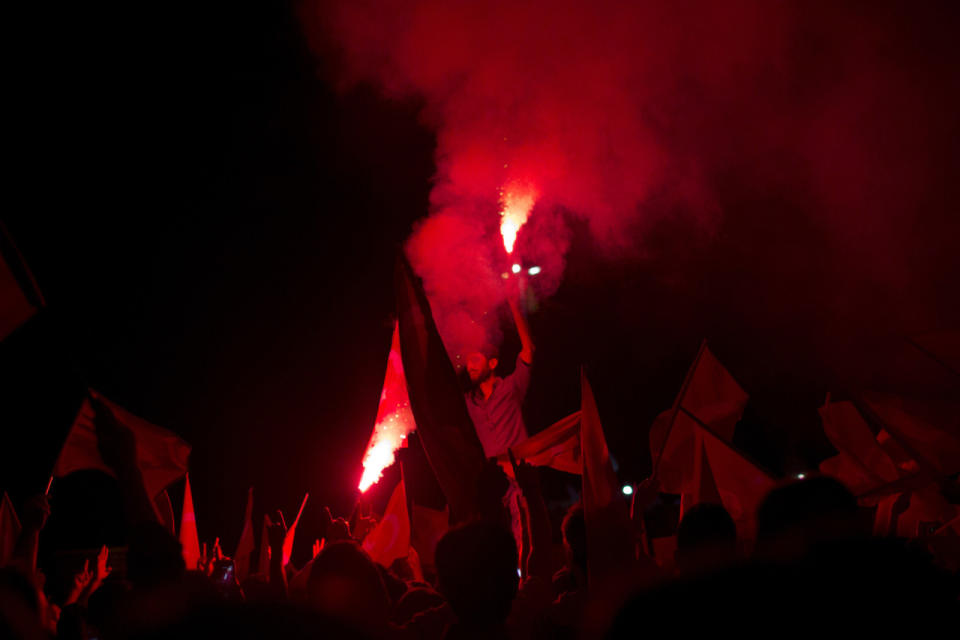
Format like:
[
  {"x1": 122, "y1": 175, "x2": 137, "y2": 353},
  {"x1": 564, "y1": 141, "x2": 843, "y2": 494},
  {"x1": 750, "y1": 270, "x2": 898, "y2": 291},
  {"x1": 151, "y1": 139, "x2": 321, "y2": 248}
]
[{"x1": 359, "y1": 325, "x2": 417, "y2": 491}]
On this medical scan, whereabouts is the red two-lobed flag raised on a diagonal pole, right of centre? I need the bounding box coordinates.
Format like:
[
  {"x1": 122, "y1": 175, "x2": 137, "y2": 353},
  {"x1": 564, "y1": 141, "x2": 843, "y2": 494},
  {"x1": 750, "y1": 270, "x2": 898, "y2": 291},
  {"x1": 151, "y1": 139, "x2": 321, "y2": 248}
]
[{"x1": 650, "y1": 340, "x2": 749, "y2": 493}]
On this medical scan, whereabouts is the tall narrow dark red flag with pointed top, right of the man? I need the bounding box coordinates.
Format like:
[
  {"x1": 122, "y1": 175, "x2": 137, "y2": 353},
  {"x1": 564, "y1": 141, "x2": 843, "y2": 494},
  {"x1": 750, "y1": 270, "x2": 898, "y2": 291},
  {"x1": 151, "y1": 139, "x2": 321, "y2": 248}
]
[{"x1": 580, "y1": 369, "x2": 634, "y2": 584}]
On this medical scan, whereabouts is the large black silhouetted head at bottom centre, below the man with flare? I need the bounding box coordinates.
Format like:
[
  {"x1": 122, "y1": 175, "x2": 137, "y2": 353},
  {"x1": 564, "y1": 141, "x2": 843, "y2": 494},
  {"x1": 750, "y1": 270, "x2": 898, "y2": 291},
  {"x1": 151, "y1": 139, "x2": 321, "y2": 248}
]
[{"x1": 435, "y1": 522, "x2": 518, "y2": 629}]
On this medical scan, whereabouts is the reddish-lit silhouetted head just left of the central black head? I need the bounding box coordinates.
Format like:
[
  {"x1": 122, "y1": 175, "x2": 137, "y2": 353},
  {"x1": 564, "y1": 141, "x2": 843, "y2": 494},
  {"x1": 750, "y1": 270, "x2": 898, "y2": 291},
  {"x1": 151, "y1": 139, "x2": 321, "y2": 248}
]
[{"x1": 307, "y1": 542, "x2": 390, "y2": 632}]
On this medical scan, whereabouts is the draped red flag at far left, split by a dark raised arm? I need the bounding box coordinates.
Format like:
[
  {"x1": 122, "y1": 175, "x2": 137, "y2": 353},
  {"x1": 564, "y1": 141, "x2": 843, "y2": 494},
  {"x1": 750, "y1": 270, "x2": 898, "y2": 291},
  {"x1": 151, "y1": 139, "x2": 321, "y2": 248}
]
[{"x1": 53, "y1": 389, "x2": 190, "y2": 498}]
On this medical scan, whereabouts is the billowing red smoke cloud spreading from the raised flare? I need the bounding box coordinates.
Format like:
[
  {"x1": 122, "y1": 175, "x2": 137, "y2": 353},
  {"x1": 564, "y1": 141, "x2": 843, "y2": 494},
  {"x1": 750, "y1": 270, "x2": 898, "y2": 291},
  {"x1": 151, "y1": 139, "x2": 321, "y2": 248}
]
[{"x1": 305, "y1": 0, "x2": 958, "y2": 360}]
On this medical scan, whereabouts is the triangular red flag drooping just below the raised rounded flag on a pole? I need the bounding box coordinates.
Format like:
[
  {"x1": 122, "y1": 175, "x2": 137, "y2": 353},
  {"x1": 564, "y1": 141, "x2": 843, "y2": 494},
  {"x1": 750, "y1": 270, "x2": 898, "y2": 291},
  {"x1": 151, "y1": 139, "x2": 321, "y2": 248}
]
[{"x1": 697, "y1": 424, "x2": 776, "y2": 540}]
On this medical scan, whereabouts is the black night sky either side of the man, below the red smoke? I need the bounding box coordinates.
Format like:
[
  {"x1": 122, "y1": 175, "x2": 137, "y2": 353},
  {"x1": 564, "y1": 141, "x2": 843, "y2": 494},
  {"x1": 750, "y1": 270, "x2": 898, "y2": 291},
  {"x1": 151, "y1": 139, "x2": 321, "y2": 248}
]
[{"x1": 0, "y1": 2, "x2": 960, "y2": 557}]
